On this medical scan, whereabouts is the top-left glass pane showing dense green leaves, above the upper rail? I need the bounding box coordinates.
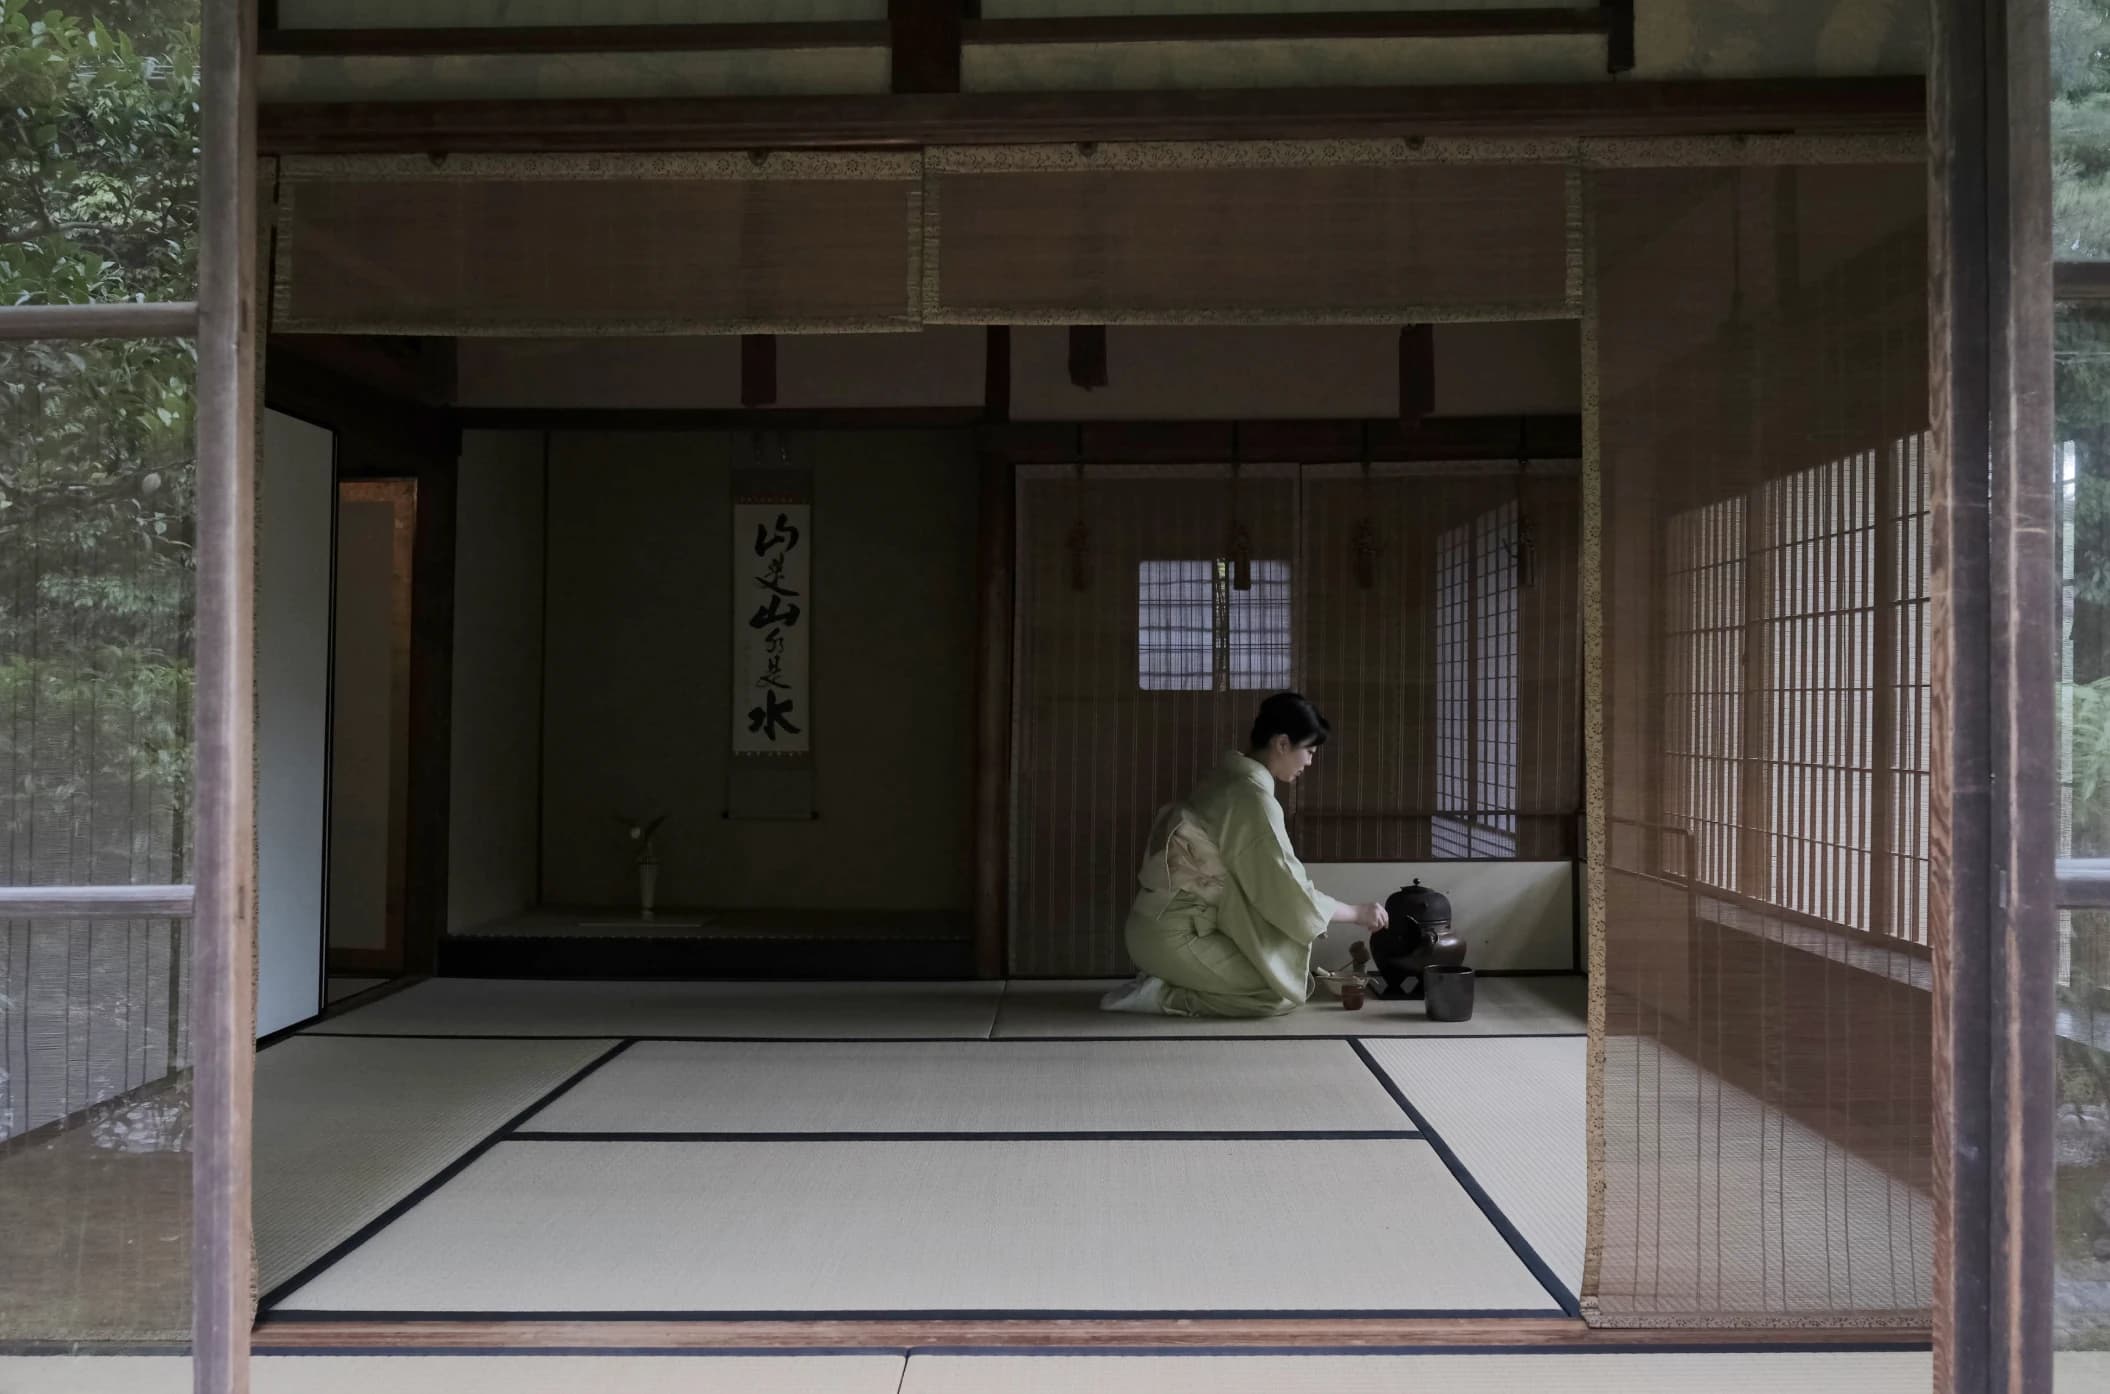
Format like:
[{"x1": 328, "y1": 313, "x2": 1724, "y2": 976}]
[{"x1": 0, "y1": 0, "x2": 198, "y2": 306}]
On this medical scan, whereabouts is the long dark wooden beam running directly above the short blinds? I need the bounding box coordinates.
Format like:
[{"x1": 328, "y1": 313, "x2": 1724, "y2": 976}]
[{"x1": 262, "y1": 78, "x2": 1926, "y2": 154}]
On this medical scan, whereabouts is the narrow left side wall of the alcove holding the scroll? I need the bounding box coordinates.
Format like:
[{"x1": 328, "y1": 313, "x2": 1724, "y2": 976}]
[{"x1": 447, "y1": 430, "x2": 544, "y2": 930}]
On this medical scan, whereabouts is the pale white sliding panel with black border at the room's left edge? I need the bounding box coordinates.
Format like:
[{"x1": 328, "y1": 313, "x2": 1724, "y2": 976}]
[{"x1": 255, "y1": 411, "x2": 338, "y2": 1035}]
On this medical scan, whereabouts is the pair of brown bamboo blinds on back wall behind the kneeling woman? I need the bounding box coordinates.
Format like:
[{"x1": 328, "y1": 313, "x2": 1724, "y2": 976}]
[{"x1": 1011, "y1": 464, "x2": 1580, "y2": 976}]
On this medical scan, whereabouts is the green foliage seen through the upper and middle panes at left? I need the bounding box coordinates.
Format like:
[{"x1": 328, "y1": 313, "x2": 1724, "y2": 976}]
[{"x1": 0, "y1": 0, "x2": 198, "y2": 884}]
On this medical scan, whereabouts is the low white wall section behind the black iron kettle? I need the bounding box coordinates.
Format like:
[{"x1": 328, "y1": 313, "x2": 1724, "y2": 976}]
[{"x1": 1306, "y1": 863, "x2": 1576, "y2": 972}]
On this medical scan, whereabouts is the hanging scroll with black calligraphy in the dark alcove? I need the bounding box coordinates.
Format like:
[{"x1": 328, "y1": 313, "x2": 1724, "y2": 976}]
[{"x1": 726, "y1": 444, "x2": 814, "y2": 818}]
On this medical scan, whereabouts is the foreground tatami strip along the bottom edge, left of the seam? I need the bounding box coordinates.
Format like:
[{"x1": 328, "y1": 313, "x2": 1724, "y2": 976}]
[{"x1": 0, "y1": 1354, "x2": 903, "y2": 1394}]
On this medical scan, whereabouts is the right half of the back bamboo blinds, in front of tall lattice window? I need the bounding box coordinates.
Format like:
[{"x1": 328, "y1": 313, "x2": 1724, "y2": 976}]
[{"x1": 1293, "y1": 462, "x2": 1583, "y2": 863}]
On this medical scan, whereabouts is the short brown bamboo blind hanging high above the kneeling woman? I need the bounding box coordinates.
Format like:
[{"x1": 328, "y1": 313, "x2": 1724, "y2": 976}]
[{"x1": 924, "y1": 143, "x2": 1578, "y2": 325}]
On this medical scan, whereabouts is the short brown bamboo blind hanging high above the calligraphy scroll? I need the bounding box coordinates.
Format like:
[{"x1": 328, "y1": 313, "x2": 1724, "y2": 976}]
[{"x1": 272, "y1": 154, "x2": 922, "y2": 335}]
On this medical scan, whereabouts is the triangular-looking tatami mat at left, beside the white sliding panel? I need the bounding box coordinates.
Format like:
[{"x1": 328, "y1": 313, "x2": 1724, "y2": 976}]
[{"x1": 255, "y1": 1035, "x2": 614, "y2": 1293}]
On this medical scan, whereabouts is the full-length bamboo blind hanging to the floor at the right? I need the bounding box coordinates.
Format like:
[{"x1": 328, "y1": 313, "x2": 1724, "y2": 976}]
[{"x1": 1587, "y1": 164, "x2": 1933, "y2": 1324}]
